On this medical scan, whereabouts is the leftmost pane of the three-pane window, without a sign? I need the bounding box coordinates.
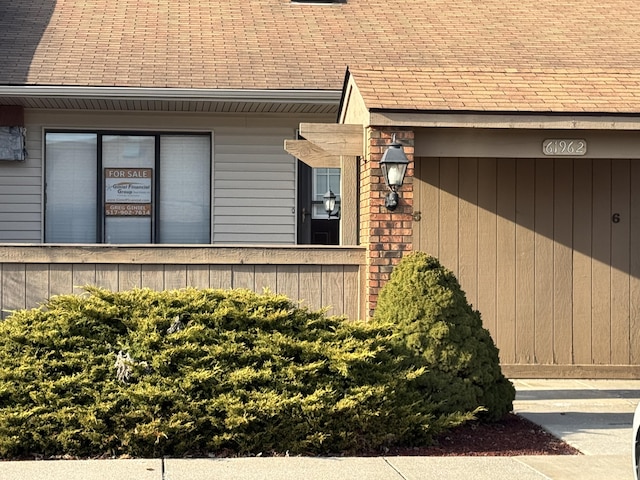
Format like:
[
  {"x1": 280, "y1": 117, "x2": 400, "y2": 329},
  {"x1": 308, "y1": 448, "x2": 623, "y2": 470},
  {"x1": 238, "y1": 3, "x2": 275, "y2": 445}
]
[{"x1": 45, "y1": 133, "x2": 98, "y2": 243}]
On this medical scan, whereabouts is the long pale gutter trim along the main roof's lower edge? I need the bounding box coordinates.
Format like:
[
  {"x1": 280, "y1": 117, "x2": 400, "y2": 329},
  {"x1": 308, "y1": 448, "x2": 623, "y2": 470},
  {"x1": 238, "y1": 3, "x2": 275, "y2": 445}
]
[{"x1": 0, "y1": 85, "x2": 342, "y2": 104}]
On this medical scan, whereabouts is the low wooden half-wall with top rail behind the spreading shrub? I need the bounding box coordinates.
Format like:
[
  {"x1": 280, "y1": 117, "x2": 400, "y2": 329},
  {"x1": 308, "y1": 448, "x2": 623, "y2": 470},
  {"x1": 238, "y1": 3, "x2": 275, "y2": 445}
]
[{"x1": 0, "y1": 245, "x2": 365, "y2": 320}]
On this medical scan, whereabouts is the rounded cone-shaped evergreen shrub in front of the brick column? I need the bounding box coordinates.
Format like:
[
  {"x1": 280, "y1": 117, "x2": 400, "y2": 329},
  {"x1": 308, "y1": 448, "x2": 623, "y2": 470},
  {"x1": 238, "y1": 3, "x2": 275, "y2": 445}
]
[{"x1": 374, "y1": 252, "x2": 515, "y2": 420}]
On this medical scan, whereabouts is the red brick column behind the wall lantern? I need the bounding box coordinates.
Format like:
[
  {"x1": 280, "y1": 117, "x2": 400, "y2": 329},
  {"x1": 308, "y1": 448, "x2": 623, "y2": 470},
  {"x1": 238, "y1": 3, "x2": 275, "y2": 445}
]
[{"x1": 360, "y1": 127, "x2": 414, "y2": 318}]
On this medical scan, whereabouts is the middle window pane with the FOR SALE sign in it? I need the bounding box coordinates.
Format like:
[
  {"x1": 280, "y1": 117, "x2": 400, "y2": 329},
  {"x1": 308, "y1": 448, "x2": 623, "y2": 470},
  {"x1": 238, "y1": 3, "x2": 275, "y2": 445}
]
[{"x1": 102, "y1": 135, "x2": 155, "y2": 243}]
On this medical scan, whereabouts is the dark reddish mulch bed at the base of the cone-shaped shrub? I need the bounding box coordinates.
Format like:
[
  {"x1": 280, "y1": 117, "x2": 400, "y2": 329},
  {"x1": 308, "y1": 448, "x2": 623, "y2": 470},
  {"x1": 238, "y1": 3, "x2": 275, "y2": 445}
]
[{"x1": 378, "y1": 414, "x2": 580, "y2": 456}]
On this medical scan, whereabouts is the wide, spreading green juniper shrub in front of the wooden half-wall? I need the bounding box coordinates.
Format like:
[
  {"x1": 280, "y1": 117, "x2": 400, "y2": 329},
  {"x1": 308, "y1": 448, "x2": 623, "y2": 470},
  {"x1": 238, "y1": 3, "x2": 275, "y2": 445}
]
[{"x1": 0, "y1": 287, "x2": 482, "y2": 458}]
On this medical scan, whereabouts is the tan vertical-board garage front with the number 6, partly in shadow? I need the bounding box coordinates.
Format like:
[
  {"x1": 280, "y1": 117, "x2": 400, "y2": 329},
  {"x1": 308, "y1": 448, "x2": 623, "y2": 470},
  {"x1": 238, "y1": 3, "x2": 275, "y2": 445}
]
[{"x1": 414, "y1": 158, "x2": 640, "y2": 366}]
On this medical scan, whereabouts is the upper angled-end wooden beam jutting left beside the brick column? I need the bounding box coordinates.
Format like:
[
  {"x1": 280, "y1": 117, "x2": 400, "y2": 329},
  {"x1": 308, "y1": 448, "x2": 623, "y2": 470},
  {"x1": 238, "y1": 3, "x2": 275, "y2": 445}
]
[{"x1": 300, "y1": 123, "x2": 364, "y2": 157}]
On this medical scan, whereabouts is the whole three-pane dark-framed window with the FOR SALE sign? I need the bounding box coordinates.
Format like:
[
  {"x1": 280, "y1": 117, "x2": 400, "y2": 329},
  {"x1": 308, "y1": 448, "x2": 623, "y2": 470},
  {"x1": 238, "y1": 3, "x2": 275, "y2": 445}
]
[{"x1": 45, "y1": 132, "x2": 211, "y2": 244}]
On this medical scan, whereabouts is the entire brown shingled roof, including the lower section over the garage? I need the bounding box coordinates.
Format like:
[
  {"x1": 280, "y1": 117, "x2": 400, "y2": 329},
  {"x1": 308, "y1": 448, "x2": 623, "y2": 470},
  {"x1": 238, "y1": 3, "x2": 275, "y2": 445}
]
[{"x1": 0, "y1": 0, "x2": 640, "y2": 112}]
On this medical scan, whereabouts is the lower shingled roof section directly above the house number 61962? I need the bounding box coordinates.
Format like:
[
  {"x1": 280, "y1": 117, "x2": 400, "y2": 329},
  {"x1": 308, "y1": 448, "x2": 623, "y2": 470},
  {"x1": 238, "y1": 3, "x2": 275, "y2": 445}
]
[{"x1": 349, "y1": 67, "x2": 640, "y2": 113}]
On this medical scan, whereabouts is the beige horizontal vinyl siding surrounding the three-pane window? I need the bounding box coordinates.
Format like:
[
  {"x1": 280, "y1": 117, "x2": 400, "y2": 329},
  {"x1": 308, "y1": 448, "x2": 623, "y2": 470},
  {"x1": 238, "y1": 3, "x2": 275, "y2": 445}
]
[{"x1": 16, "y1": 110, "x2": 335, "y2": 244}]
